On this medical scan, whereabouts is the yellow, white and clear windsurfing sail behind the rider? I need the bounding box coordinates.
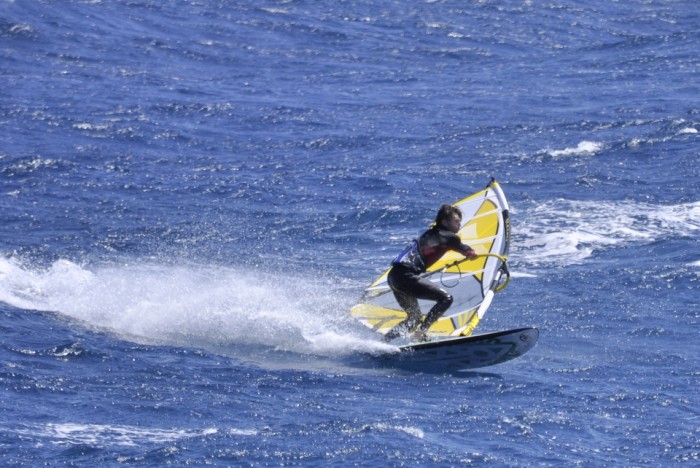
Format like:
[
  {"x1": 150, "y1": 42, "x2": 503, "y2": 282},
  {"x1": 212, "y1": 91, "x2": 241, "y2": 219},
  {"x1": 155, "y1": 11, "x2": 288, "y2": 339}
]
[{"x1": 351, "y1": 179, "x2": 510, "y2": 338}]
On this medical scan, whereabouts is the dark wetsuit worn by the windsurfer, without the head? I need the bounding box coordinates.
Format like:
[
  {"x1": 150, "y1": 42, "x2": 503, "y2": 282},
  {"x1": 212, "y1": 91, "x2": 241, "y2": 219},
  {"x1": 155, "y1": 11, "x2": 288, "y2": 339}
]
[{"x1": 384, "y1": 226, "x2": 473, "y2": 340}]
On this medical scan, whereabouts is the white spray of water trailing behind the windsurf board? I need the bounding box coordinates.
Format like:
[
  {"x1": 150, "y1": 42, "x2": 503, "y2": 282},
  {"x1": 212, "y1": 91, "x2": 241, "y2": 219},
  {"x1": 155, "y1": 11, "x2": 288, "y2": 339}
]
[{"x1": 0, "y1": 258, "x2": 394, "y2": 356}]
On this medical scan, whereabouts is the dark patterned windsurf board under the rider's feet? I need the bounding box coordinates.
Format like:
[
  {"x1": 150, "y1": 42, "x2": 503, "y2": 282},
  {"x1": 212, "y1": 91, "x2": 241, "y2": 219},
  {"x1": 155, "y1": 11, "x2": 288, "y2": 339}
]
[{"x1": 392, "y1": 328, "x2": 539, "y2": 371}]
